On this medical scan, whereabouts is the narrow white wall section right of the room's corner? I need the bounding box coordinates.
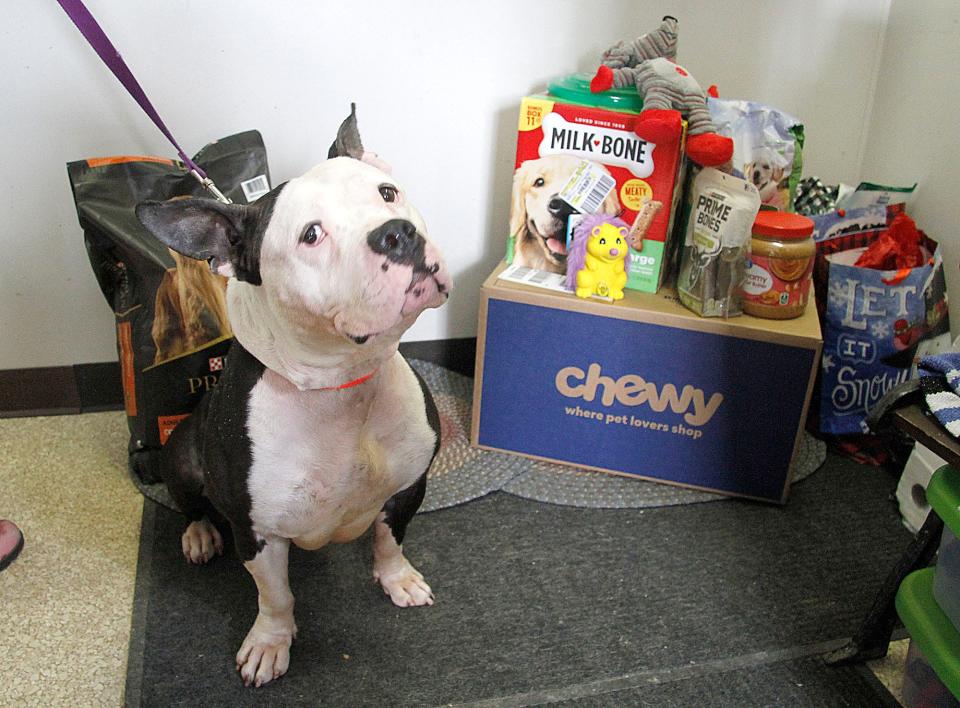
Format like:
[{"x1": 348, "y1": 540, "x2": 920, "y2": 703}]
[{"x1": 862, "y1": 0, "x2": 960, "y2": 337}]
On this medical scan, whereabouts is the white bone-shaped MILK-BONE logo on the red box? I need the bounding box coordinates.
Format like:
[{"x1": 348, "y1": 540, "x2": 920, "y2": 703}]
[{"x1": 540, "y1": 113, "x2": 656, "y2": 177}]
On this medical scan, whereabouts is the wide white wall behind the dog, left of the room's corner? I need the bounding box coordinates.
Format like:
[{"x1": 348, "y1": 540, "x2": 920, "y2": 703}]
[{"x1": 0, "y1": 0, "x2": 896, "y2": 369}]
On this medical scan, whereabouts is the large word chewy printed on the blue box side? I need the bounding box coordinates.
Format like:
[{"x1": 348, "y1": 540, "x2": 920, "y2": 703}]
[{"x1": 554, "y1": 363, "x2": 723, "y2": 425}]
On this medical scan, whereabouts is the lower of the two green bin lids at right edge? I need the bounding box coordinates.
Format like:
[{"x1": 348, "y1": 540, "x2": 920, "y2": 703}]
[{"x1": 897, "y1": 568, "x2": 960, "y2": 698}]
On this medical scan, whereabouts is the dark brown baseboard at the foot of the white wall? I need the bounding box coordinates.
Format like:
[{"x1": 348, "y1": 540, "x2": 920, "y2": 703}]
[{"x1": 0, "y1": 337, "x2": 477, "y2": 418}]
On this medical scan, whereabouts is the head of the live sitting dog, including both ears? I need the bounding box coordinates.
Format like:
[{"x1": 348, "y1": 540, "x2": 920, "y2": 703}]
[{"x1": 137, "y1": 103, "x2": 452, "y2": 384}]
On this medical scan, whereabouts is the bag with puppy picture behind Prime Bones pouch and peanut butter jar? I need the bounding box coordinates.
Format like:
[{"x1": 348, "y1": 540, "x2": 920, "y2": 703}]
[{"x1": 707, "y1": 98, "x2": 803, "y2": 211}]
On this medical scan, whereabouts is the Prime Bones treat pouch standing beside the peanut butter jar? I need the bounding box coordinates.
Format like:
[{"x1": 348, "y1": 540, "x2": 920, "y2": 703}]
[{"x1": 677, "y1": 167, "x2": 760, "y2": 317}]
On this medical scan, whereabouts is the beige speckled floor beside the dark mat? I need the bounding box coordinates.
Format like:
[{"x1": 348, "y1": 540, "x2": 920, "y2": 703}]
[{"x1": 0, "y1": 412, "x2": 907, "y2": 706}]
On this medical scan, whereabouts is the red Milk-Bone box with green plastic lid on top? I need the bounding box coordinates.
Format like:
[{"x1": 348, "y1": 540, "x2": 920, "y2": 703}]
[{"x1": 507, "y1": 76, "x2": 684, "y2": 292}]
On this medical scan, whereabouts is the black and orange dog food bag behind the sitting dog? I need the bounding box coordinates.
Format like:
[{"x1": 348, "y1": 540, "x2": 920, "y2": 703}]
[{"x1": 67, "y1": 131, "x2": 270, "y2": 483}]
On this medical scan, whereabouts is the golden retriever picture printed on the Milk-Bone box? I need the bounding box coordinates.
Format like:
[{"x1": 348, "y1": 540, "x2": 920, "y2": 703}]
[{"x1": 510, "y1": 155, "x2": 620, "y2": 273}]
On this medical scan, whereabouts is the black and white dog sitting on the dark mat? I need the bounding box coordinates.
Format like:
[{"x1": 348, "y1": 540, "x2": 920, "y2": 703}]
[{"x1": 137, "y1": 110, "x2": 452, "y2": 686}]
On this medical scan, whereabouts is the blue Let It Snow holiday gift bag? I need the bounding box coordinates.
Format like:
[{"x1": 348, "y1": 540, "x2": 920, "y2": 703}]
[{"x1": 820, "y1": 232, "x2": 950, "y2": 435}]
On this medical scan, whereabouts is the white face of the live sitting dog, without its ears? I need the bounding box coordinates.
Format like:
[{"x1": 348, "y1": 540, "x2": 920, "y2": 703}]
[{"x1": 260, "y1": 157, "x2": 452, "y2": 344}]
